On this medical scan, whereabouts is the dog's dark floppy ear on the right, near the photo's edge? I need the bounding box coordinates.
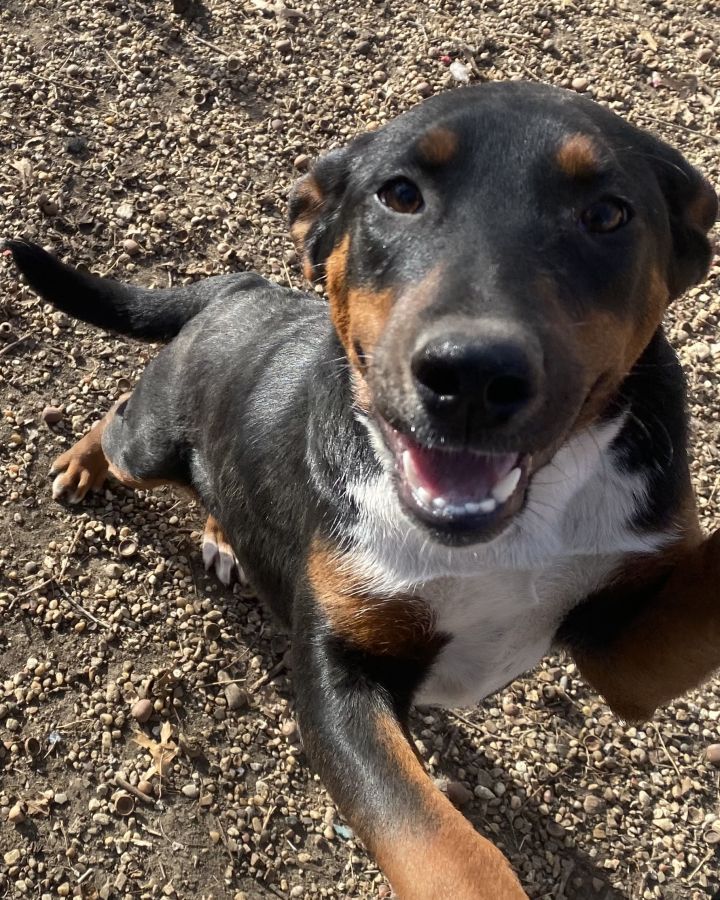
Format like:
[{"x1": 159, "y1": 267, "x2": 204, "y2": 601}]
[{"x1": 647, "y1": 138, "x2": 718, "y2": 299}]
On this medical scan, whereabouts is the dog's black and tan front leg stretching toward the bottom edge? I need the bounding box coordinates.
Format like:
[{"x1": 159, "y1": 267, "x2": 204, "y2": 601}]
[{"x1": 293, "y1": 544, "x2": 527, "y2": 900}]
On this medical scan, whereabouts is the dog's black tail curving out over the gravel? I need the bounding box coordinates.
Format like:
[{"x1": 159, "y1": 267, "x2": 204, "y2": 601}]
[{"x1": 0, "y1": 240, "x2": 245, "y2": 341}]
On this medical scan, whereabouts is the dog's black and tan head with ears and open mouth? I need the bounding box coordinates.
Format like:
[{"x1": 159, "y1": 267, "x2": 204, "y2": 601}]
[{"x1": 290, "y1": 83, "x2": 717, "y2": 542}]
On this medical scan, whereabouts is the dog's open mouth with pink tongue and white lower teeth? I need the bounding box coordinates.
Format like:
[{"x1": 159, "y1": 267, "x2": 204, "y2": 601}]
[{"x1": 383, "y1": 425, "x2": 529, "y2": 531}]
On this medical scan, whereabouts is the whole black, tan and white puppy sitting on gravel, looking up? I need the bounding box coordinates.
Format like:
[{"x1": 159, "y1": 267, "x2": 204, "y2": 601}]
[{"x1": 7, "y1": 83, "x2": 720, "y2": 900}]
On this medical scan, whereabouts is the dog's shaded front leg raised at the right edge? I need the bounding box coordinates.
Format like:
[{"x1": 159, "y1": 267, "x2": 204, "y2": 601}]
[{"x1": 560, "y1": 531, "x2": 720, "y2": 721}]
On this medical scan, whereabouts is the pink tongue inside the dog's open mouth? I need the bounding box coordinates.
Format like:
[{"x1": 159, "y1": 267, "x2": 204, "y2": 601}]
[{"x1": 400, "y1": 437, "x2": 518, "y2": 504}]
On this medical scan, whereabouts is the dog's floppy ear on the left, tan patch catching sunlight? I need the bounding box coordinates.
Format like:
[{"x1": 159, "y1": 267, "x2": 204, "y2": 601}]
[{"x1": 289, "y1": 133, "x2": 374, "y2": 281}]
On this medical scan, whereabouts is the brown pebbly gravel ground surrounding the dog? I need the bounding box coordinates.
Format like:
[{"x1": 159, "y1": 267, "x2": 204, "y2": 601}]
[{"x1": 0, "y1": 0, "x2": 720, "y2": 900}]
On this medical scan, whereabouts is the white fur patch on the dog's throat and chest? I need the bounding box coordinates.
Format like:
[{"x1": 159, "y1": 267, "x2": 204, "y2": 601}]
[{"x1": 345, "y1": 418, "x2": 671, "y2": 706}]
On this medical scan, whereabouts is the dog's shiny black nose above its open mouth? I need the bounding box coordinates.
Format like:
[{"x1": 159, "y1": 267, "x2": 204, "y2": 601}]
[{"x1": 411, "y1": 334, "x2": 540, "y2": 428}]
